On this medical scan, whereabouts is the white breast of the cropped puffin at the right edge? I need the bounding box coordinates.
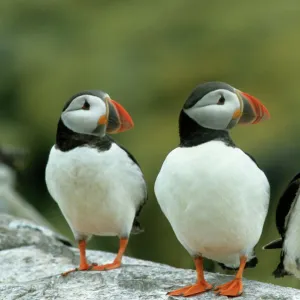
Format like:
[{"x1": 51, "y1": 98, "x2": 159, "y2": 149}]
[{"x1": 283, "y1": 195, "x2": 300, "y2": 279}]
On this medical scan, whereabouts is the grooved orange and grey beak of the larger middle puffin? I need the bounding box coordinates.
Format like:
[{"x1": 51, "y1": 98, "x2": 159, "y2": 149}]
[{"x1": 232, "y1": 90, "x2": 270, "y2": 124}]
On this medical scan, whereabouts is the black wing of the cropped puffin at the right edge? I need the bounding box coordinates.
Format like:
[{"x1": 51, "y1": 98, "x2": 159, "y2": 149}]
[{"x1": 276, "y1": 173, "x2": 300, "y2": 238}]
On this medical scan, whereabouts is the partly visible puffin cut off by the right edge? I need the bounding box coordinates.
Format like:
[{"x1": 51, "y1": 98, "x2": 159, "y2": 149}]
[{"x1": 263, "y1": 173, "x2": 300, "y2": 279}]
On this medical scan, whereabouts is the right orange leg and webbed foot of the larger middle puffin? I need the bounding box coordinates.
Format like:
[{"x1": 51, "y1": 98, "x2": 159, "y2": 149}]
[{"x1": 215, "y1": 256, "x2": 247, "y2": 297}]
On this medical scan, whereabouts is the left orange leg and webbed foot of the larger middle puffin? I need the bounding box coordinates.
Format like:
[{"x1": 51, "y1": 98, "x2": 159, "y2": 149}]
[{"x1": 168, "y1": 257, "x2": 212, "y2": 297}]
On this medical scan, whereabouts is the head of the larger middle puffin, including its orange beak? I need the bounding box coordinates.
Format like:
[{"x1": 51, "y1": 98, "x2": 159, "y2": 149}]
[{"x1": 182, "y1": 82, "x2": 270, "y2": 130}]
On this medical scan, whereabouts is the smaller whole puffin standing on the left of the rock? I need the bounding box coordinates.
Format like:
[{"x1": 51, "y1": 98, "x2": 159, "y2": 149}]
[{"x1": 45, "y1": 90, "x2": 147, "y2": 276}]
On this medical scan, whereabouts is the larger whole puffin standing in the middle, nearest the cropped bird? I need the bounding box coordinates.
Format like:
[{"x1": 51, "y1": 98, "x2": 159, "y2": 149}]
[{"x1": 154, "y1": 82, "x2": 270, "y2": 297}]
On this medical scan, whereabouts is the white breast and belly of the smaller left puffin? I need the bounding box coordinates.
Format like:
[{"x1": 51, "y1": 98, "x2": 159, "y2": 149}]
[{"x1": 46, "y1": 144, "x2": 145, "y2": 236}]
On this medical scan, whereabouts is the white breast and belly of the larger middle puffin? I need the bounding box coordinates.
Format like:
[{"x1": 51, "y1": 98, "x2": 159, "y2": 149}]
[{"x1": 155, "y1": 141, "x2": 269, "y2": 265}]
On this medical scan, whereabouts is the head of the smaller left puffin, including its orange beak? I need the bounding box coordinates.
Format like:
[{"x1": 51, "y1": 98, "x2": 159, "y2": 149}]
[{"x1": 61, "y1": 91, "x2": 134, "y2": 137}]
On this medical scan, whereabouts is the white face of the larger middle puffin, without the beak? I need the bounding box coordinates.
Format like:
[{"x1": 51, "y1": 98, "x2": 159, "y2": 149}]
[{"x1": 184, "y1": 89, "x2": 242, "y2": 130}]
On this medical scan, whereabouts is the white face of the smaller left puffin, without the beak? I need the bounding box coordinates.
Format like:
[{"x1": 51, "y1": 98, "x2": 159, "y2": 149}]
[{"x1": 61, "y1": 94, "x2": 109, "y2": 135}]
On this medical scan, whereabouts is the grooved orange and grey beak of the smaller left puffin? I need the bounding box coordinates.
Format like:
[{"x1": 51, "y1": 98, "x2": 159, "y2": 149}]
[{"x1": 98, "y1": 97, "x2": 134, "y2": 134}]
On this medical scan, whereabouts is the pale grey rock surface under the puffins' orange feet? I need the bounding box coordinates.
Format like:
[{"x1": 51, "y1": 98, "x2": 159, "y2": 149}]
[{"x1": 0, "y1": 215, "x2": 300, "y2": 300}]
